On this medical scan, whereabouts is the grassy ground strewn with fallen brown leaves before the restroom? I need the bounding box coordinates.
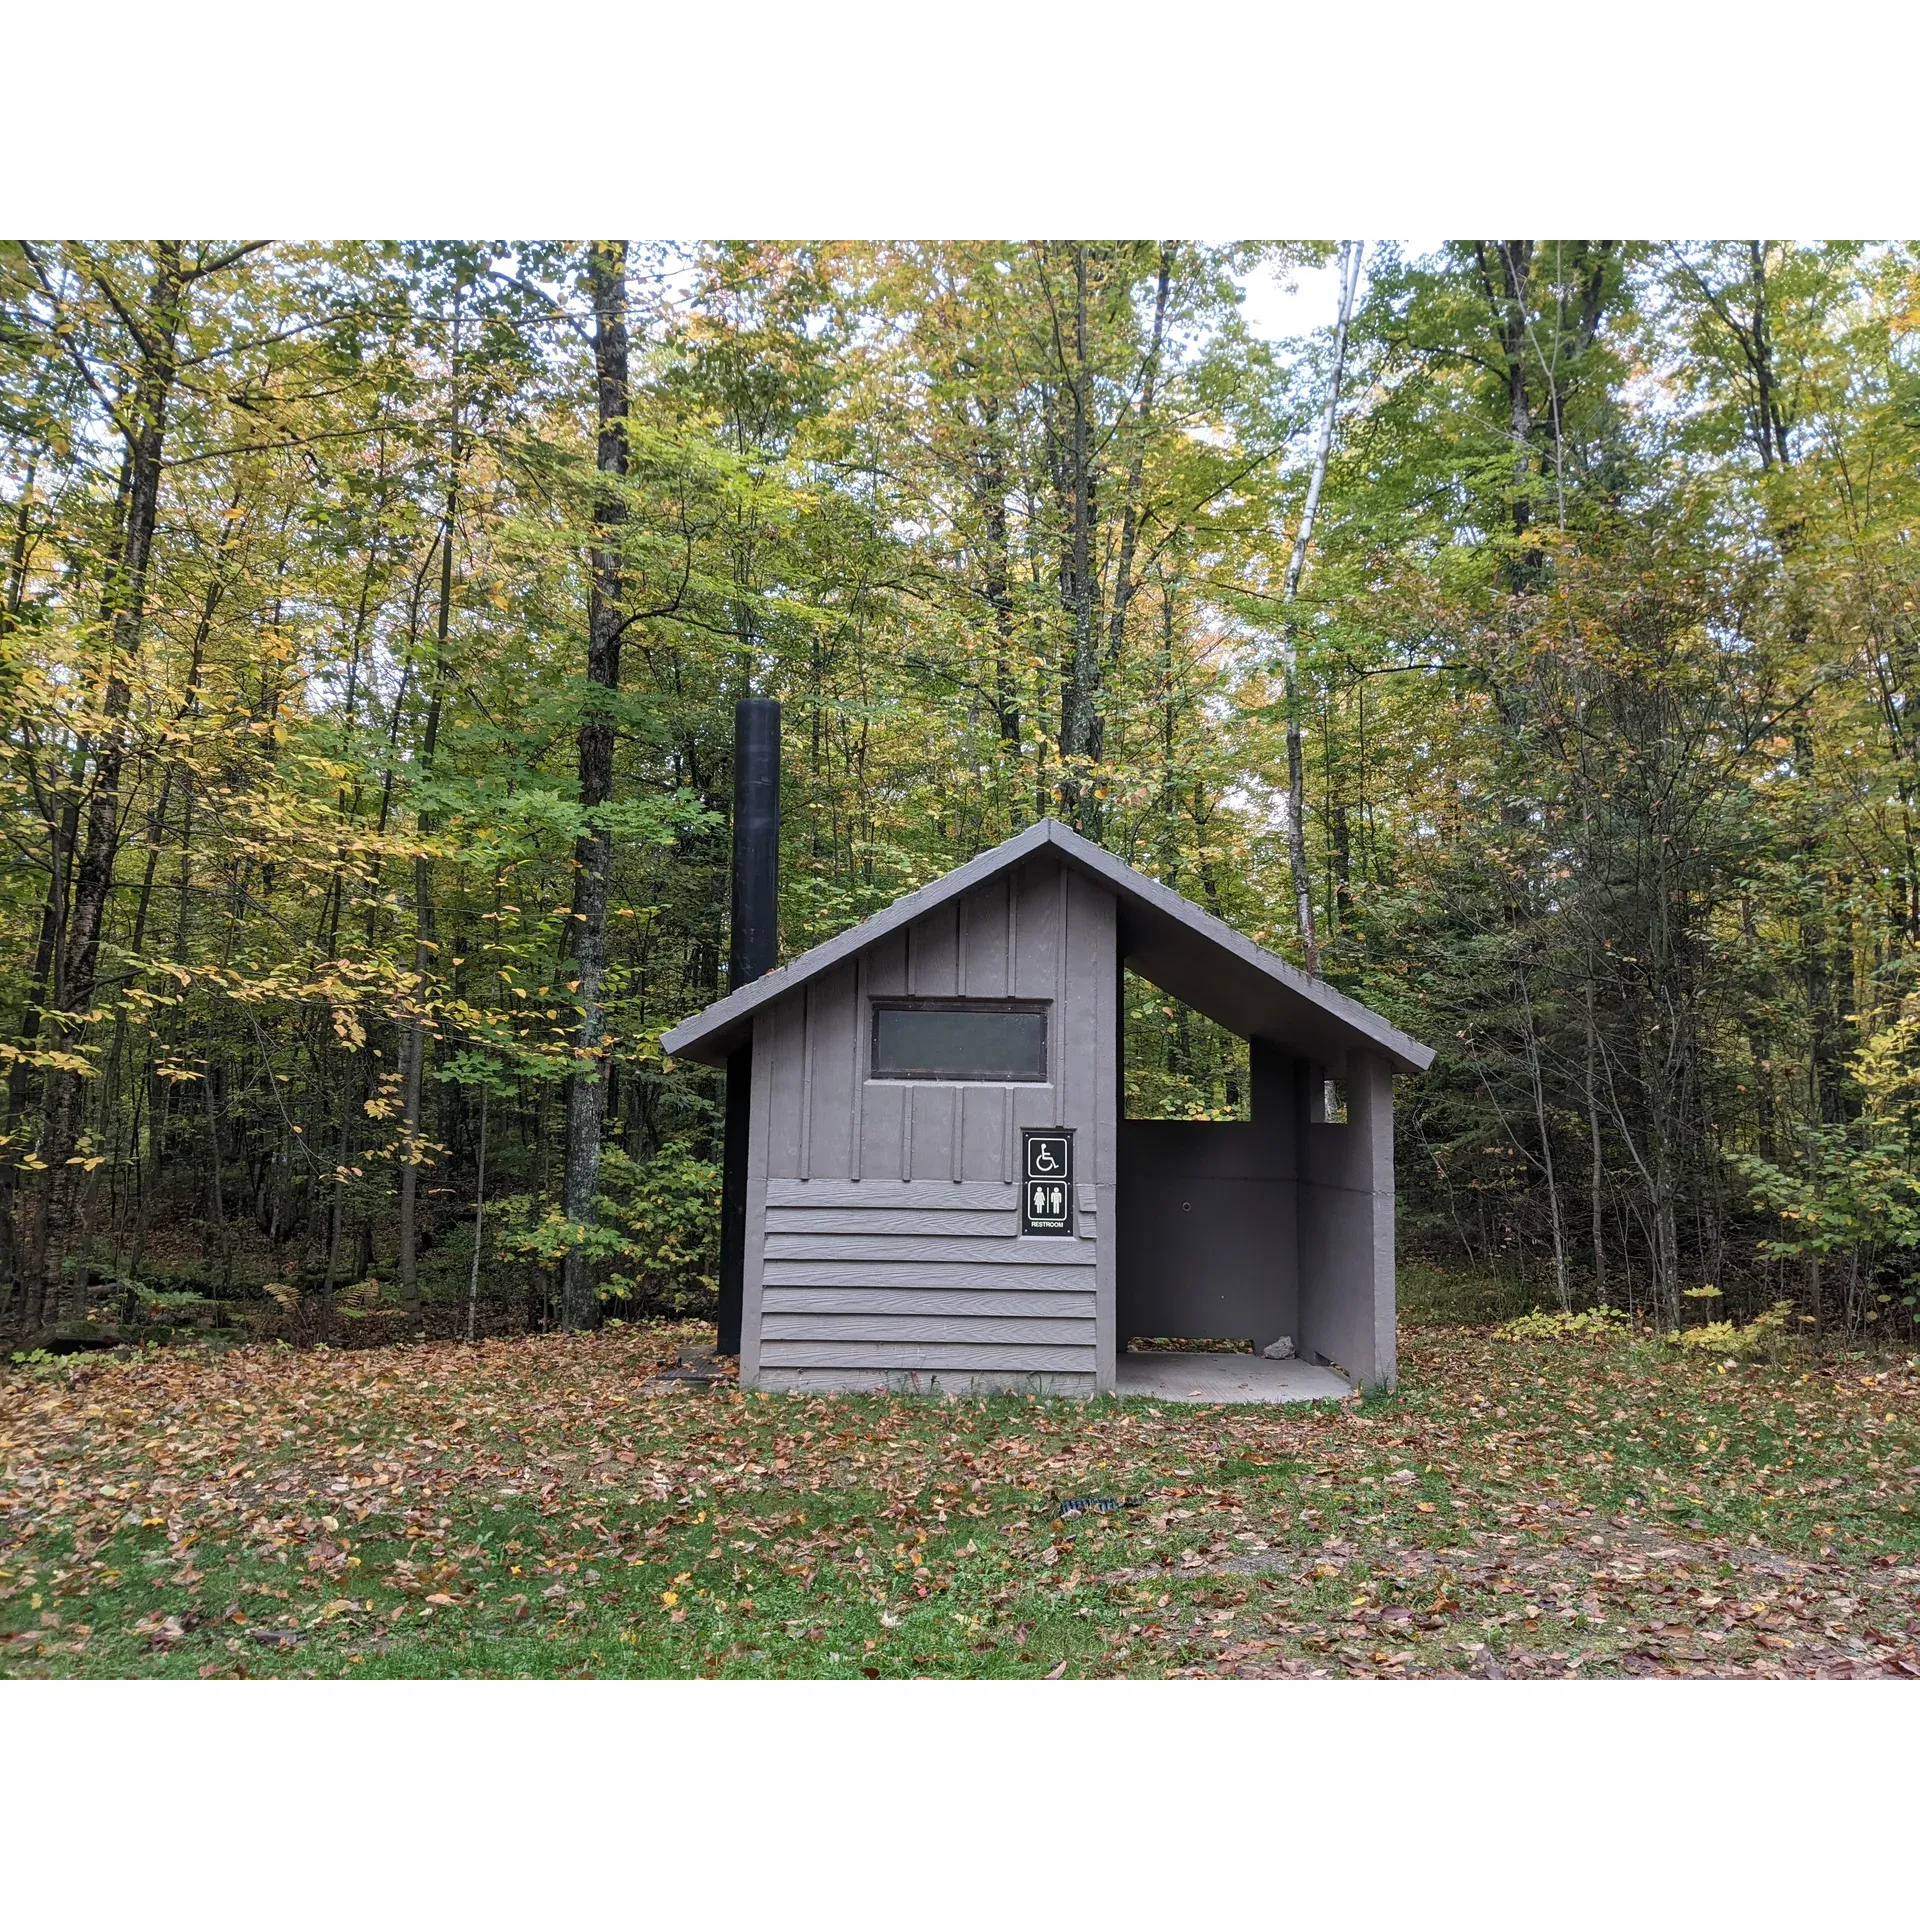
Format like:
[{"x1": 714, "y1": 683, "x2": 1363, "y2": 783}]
[{"x1": 0, "y1": 1329, "x2": 1920, "y2": 1676}]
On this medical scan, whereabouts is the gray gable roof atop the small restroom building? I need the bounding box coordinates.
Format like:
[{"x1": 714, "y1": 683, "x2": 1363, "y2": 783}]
[{"x1": 660, "y1": 820, "x2": 1434, "y2": 1073}]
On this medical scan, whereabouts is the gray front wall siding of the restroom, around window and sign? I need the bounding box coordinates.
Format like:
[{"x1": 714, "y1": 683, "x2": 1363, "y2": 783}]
[{"x1": 741, "y1": 860, "x2": 1117, "y2": 1392}]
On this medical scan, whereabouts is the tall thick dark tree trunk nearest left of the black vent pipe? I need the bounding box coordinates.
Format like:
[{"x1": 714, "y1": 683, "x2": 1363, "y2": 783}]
[{"x1": 561, "y1": 240, "x2": 628, "y2": 1332}]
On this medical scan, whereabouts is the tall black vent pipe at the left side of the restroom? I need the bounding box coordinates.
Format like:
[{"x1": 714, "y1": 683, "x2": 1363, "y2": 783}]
[{"x1": 714, "y1": 701, "x2": 780, "y2": 1354}]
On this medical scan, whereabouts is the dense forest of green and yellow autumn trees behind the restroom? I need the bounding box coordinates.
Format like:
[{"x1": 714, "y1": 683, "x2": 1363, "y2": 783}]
[{"x1": 0, "y1": 240, "x2": 1920, "y2": 1340}]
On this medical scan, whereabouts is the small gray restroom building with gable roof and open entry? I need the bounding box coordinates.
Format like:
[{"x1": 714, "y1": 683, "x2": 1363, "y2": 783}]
[{"x1": 664, "y1": 820, "x2": 1432, "y2": 1394}]
